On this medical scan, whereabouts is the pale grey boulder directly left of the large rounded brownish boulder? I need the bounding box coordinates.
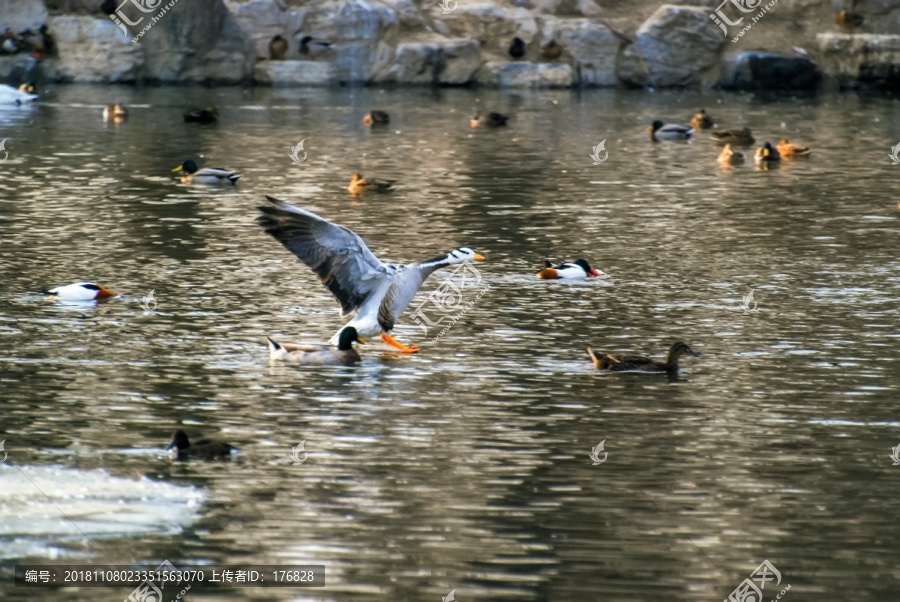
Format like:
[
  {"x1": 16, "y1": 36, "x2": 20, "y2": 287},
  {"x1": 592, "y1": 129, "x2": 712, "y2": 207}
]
[{"x1": 539, "y1": 17, "x2": 622, "y2": 86}]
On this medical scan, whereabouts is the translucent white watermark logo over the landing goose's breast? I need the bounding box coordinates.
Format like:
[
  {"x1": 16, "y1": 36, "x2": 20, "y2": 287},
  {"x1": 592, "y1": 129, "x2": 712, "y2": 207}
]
[{"x1": 412, "y1": 260, "x2": 491, "y2": 343}]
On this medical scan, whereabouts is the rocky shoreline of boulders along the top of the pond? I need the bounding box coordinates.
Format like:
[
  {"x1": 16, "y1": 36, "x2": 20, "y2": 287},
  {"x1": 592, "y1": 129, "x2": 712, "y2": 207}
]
[{"x1": 0, "y1": 0, "x2": 900, "y2": 90}]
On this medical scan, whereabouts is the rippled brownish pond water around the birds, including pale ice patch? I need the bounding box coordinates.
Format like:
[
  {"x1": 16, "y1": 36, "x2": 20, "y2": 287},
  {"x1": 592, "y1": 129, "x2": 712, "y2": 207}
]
[{"x1": 0, "y1": 87, "x2": 900, "y2": 602}]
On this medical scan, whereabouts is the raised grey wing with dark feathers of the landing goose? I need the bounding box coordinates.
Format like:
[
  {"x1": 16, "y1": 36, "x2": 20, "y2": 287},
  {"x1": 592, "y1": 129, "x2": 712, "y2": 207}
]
[{"x1": 256, "y1": 196, "x2": 390, "y2": 315}]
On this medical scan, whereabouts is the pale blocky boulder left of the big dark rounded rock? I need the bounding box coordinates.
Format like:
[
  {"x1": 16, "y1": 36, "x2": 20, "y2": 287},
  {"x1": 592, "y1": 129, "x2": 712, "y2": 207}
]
[{"x1": 47, "y1": 17, "x2": 144, "y2": 83}]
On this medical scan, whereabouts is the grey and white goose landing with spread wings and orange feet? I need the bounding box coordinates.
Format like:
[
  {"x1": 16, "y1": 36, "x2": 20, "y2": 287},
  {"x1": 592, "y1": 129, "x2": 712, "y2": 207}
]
[{"x1": 256, "y1": 195, "x2": 485, "y2": 353}]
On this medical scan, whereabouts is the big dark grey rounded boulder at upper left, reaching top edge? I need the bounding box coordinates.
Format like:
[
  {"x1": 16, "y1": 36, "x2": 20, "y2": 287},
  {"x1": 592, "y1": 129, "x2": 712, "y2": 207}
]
[{"x1": 123, "y1": 0, "x2": 256, "y2": 84}]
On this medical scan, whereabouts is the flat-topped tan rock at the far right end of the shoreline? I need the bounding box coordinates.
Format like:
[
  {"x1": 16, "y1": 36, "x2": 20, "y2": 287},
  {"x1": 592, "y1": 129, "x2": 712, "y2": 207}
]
[{"x1": 816, "y1": 33, "x2": 900, "y2": 90}]
